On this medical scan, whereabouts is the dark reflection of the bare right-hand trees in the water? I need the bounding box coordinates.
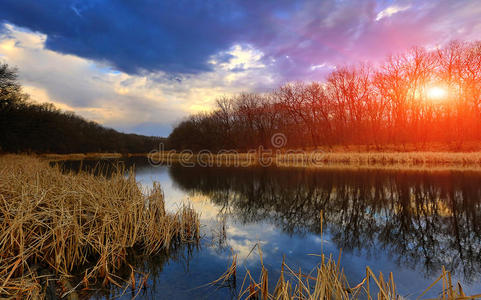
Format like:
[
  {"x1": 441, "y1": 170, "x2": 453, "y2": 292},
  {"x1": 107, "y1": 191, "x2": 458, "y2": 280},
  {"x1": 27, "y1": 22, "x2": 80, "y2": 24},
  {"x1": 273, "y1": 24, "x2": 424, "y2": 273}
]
[{"x1": 170, "y1": 166, "x2": 481, "y2": 281}]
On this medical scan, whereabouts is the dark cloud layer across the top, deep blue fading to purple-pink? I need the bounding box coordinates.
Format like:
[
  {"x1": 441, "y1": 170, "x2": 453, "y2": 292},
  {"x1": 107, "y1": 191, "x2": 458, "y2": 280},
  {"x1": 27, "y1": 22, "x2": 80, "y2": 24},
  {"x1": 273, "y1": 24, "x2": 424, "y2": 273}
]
[{"x1": 0, "y1": 0, "x2": 481, "y2": 80}]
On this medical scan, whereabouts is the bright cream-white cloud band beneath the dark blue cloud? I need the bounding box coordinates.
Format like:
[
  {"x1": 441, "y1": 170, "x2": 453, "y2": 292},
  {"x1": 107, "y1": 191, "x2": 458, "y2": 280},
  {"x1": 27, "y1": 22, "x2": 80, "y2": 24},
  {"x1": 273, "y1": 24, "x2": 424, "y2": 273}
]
[{"x1": 0, "y1": 25, "x2": 275, "y2": 135}]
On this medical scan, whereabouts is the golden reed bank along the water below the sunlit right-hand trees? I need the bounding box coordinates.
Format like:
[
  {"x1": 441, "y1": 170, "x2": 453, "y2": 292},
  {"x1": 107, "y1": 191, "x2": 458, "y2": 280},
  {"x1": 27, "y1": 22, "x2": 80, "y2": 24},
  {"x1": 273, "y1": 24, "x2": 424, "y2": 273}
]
[{"x1": 150, "y1": 150, "x2": 481, "y2": 170}]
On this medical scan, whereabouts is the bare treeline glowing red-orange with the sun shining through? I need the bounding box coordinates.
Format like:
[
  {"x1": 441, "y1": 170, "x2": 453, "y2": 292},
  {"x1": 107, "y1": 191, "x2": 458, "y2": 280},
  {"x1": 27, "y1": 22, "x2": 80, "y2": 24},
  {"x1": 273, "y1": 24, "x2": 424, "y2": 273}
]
[{"x1": 169, "y1": 42, "x2": 481, "y2": 151}]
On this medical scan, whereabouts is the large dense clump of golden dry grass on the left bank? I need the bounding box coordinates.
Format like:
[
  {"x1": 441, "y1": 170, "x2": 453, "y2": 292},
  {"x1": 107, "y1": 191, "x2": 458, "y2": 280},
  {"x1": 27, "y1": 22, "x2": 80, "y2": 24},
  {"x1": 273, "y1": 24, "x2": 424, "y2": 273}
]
[{"x1": 0, "y1": 155, "x2": 199, "y2": 298}]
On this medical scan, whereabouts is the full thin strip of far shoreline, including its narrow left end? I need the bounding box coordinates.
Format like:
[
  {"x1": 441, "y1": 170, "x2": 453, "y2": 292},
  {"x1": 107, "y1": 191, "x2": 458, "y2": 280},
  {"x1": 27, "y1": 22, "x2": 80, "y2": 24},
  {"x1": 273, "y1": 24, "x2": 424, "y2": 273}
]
[{"x1": 15, "y1": 149, "x2": 481, "y2": 171}]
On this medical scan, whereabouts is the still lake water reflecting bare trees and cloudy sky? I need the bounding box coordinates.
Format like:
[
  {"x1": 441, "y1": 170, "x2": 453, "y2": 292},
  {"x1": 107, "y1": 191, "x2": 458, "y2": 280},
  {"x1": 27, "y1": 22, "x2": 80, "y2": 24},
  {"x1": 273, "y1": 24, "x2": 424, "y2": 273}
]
[{"x1": 59, "y1": 159, "x2": 481, "y2": 299}]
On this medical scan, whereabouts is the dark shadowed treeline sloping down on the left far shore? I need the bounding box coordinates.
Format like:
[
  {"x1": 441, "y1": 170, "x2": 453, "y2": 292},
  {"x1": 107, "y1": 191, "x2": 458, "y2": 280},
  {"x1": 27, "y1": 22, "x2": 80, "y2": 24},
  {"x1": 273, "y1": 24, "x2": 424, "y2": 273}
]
[{"x1": 0, "y1": 64, "x2": 163, "y2": 153}]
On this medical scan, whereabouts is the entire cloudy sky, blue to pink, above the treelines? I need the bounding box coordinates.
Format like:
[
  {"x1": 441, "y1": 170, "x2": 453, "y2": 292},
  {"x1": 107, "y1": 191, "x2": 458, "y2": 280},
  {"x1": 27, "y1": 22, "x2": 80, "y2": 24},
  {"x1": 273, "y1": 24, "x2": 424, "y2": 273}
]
[{"x1": 0, "y1": 0, "x2": 481, "y2": 136}]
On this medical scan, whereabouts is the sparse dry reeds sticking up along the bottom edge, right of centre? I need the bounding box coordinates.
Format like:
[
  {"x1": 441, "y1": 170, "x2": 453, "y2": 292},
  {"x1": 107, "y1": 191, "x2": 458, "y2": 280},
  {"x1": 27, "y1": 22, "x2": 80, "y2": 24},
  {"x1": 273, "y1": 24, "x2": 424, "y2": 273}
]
[{"x1": 220, "y1": 245, "x2": 481, "y2": 300}]
